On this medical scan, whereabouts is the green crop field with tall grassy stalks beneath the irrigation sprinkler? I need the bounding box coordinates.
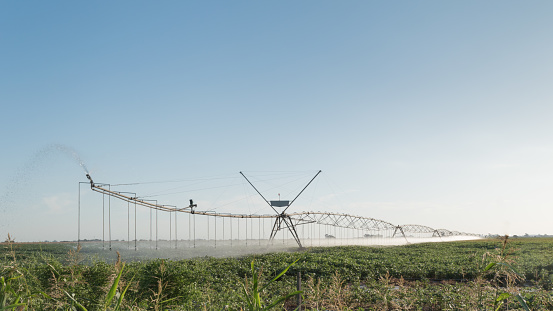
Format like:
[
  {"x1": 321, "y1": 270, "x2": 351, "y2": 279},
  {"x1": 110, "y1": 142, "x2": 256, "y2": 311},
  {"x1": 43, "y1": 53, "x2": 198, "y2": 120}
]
[{"x1": 0, "y1": 238, "x2": 553, "y2": 310}]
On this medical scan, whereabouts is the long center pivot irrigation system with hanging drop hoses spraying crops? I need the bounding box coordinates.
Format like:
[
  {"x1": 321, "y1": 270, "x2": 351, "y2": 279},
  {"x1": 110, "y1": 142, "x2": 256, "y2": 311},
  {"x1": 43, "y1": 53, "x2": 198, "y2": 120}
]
[{"x1": 78, "y1": 171, "x2": 479, "y2": 250}]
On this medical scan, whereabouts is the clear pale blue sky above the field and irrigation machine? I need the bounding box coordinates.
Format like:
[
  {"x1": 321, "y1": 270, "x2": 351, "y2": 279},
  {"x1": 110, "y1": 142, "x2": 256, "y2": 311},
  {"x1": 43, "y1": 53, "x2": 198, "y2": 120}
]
[{"x1": 0, "y1": 1, "x2": 553, "y2": 240}]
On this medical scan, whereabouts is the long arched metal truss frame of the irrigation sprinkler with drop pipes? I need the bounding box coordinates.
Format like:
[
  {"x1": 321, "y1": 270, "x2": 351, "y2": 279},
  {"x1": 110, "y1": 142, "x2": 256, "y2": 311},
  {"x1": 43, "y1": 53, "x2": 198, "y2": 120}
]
[{"x1": 78, "y1": 171, "x2": 480, "y2": 250}]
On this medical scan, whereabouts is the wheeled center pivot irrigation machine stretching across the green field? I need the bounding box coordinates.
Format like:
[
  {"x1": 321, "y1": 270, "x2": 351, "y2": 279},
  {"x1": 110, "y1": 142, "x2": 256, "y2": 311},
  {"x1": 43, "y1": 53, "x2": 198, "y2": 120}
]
[{"x1": 78, "y1": 171, "x2": 478, "y2": 249}]
